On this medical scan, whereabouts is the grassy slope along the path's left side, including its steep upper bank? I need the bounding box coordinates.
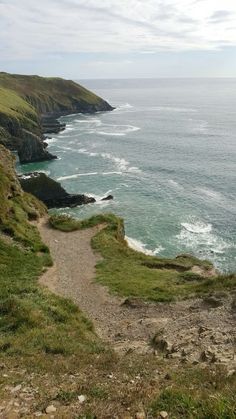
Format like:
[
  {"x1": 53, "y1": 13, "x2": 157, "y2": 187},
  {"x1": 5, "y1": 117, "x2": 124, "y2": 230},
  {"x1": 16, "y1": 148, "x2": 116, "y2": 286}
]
[{"x1": 0, "y1": 146, "x2": 100, "y2": 355}]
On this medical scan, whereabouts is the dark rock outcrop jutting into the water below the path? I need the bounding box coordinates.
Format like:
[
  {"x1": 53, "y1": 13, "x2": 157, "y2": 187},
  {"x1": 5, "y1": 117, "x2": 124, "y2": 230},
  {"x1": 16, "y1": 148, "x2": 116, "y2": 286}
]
[{"x1": 18, "y1": 172, "x2": 95, "y2": 208}]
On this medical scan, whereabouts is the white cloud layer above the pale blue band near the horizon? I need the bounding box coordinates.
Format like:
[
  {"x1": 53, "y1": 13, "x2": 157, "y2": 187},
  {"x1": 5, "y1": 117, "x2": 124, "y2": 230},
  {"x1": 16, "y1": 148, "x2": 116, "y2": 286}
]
[{"x1": 0, "y1": 0, "x2": 236, "y2": 60}]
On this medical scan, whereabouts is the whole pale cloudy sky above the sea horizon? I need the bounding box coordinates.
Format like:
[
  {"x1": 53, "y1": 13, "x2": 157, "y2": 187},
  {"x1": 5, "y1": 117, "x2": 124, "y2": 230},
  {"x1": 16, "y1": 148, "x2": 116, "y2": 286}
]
[{"x1": 0, "y1": 0, "x2": 236, "y2": 79}]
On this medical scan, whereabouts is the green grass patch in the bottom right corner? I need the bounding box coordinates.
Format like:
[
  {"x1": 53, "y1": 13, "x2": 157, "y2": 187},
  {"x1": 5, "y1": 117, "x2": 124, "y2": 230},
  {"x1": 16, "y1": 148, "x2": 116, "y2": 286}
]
[{"x1": 149, "y1": 367, "x2": 236, "y2": 419}]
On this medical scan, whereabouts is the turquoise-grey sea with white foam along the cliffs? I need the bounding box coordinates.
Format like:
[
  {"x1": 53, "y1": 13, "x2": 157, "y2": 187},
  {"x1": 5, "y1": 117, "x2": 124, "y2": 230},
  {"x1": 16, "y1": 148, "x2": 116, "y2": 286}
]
[{"x1": 20, "y1": 79, "x2": 236, "y2": 271}]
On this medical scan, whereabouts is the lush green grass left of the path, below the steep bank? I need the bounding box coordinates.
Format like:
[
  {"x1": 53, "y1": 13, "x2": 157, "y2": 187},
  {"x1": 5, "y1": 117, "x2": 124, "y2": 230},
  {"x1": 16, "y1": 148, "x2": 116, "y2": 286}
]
[{"x1": 0, "y1": 235, "x2": 104, "y2": 355}]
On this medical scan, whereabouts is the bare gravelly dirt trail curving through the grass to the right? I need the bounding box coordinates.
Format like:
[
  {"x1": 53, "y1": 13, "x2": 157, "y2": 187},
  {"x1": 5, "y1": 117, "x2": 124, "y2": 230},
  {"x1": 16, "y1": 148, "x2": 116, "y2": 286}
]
[{"x1": 38, "y1": 219, "x2": 236, "y2": 369}]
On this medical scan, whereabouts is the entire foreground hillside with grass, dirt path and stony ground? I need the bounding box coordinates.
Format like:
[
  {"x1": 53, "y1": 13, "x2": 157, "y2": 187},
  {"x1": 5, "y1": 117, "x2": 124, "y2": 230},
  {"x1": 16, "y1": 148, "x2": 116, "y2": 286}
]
[{"x1": 0, "y1": 146, "x2": 236, "y2": 419}]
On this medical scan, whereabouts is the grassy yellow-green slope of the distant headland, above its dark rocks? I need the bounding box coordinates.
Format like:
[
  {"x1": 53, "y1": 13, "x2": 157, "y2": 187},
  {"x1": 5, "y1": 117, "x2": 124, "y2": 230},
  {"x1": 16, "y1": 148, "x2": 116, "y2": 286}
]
[{"x1": 0, "y1": 72, "x2": 109, "y2": 158}]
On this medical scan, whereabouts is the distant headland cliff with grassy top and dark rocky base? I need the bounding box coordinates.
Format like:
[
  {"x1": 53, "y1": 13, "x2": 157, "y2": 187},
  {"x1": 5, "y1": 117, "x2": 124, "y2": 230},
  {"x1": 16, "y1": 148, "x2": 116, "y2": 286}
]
[{"x1": 0, "y1": 73, "x2": 113, "y2": 163}]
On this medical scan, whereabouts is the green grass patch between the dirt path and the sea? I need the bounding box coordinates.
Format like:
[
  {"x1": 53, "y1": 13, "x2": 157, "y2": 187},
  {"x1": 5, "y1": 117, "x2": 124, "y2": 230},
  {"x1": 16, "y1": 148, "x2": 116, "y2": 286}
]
[{"x1": 50, "y1": 214, "x2": 236, "y2": 302}]
